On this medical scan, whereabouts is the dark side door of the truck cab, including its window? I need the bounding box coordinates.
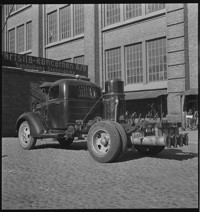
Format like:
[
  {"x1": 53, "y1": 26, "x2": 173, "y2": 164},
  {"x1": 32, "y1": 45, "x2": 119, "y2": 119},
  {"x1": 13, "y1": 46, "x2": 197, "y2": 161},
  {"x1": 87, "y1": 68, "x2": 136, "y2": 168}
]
[{"x1": 47, "y1": 85, "x2": 62, "y2": 129}]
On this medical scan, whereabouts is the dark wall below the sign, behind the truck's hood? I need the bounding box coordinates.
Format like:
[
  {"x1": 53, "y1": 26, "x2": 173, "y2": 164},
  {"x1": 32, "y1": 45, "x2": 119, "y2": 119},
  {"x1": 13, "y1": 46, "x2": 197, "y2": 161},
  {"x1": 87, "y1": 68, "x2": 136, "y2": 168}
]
[{"x1": 2, "y1": 68, "x2": 74, "y2": 137}]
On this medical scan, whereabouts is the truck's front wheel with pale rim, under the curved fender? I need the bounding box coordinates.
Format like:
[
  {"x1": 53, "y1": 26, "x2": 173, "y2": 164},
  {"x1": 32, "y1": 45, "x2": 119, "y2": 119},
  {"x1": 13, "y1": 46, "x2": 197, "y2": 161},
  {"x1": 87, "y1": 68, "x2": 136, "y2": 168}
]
[{"x1": 18, "y1": 121, "x2": 36, "y2": 150}]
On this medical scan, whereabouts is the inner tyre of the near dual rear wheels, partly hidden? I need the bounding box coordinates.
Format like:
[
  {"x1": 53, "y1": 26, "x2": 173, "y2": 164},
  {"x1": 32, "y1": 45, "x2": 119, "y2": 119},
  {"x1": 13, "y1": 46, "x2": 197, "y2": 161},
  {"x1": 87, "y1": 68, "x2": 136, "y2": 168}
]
[{"x1": 110, "y1": 121, "x2": 128, "y2": 159}]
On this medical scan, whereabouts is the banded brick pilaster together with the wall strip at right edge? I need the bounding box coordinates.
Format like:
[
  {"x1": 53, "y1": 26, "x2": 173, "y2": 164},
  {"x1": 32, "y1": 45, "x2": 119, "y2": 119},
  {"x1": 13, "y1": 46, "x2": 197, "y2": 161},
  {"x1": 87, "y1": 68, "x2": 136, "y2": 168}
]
[{"x1": 166, "y1": 4, "x2": 198, "y2": 125}]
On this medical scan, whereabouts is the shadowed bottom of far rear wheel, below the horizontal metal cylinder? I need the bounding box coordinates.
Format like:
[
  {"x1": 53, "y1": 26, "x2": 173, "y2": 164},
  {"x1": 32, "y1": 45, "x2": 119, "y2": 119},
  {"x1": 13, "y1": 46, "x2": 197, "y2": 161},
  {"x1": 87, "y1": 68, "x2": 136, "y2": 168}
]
[{"x1": 134, "y1": 145, "x2": 165, "y2": 156}]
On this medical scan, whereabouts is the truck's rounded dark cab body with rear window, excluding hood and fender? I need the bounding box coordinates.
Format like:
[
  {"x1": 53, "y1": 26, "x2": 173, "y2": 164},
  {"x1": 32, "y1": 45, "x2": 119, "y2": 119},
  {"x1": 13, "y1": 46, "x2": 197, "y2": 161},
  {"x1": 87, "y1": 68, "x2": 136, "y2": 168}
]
[{"x1": 46, "y1": 79, "x2": 103, "y2": 129}]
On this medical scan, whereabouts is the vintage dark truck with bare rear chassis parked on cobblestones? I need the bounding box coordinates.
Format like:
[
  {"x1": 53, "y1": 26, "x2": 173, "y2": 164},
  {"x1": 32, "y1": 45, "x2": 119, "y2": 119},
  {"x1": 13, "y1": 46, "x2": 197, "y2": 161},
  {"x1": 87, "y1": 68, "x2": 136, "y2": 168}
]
[{"x1": 16, "y1": 77, "x2": 188, "y2": 163}]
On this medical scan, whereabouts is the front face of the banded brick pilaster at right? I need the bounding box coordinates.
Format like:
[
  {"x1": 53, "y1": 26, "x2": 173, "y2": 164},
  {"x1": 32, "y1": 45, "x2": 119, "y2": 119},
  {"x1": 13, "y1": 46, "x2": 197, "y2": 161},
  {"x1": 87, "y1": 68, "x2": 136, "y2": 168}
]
[{"x1": 166, "y1": 4, "x2": 188, "y2": 121}]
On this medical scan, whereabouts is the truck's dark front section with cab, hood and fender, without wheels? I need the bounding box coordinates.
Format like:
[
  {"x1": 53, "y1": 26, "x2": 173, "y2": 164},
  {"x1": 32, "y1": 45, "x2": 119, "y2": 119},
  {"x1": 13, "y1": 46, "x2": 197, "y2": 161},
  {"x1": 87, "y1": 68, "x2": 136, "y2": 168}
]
[{"x1": 16, "y1": 78, "x2": 103, "y2": 147}]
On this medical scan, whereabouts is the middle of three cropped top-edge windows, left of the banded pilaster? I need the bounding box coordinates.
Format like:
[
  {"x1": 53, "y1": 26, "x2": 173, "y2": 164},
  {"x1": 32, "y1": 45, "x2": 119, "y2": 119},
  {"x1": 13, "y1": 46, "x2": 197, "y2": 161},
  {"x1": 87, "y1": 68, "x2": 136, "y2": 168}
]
[{"x1": 125, "y1": 4, "x2": 142, "y2": 19}]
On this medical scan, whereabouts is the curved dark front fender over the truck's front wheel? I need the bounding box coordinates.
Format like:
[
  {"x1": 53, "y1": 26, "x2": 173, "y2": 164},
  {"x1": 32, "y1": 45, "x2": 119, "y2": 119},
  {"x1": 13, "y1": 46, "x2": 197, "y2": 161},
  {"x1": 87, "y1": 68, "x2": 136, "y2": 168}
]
[{"x1": 16, "y1": 112, "x2": 48, "y2": 138}]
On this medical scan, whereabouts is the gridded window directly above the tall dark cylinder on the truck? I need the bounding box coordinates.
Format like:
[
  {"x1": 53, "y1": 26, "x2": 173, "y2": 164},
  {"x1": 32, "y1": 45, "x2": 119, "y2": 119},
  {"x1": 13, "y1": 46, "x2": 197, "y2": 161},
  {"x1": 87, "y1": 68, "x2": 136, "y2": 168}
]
[{"x1": 106, "y1": 48, "x2": 121, "y2": 79}]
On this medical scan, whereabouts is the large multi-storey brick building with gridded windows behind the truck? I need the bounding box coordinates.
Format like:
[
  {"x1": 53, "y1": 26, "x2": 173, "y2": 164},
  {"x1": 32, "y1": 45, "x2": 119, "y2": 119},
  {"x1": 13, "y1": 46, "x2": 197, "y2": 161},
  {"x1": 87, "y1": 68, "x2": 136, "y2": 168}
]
[{"x1": 2, "y1": 4, "x2": 198, "y2": 128}]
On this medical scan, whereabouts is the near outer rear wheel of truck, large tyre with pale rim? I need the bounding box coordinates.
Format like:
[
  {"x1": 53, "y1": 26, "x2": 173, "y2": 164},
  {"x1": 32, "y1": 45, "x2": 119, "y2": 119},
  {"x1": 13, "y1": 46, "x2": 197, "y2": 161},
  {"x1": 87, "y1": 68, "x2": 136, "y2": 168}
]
[{"x1": 87, "y1": 121, "x2": 122, "y2": 163}]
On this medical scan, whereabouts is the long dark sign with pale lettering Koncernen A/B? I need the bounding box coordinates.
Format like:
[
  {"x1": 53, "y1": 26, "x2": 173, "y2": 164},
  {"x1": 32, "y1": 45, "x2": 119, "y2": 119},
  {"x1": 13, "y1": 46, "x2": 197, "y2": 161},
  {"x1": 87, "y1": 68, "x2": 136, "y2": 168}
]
[{"x1": 2, "y1": 52, "x2": 88, "y2": 77}]
